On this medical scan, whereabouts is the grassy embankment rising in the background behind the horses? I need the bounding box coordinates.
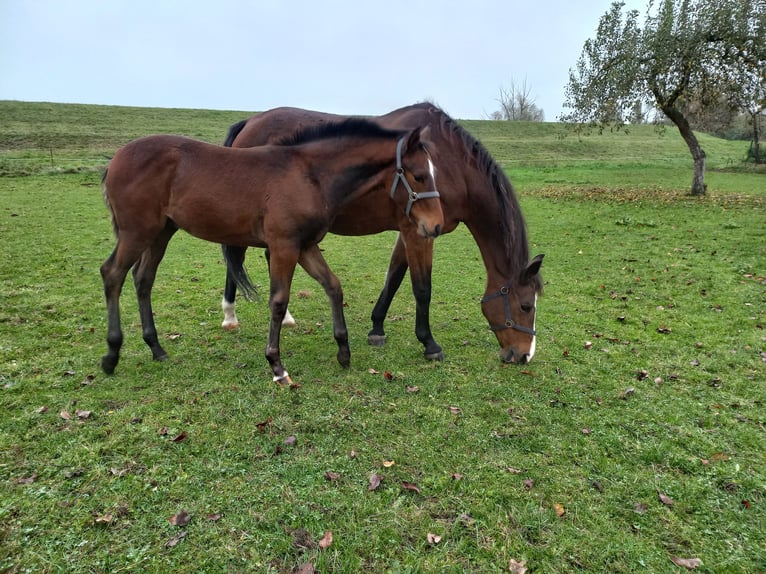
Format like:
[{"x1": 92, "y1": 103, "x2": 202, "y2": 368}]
[{"x1": 0, "y1": 101, "x2": 764, "y2": 197}]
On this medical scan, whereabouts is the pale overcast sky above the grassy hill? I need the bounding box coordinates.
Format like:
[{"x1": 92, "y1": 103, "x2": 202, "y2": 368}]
[{"x1": 0, "y1": 0, "x2": 647, "y2": 122}]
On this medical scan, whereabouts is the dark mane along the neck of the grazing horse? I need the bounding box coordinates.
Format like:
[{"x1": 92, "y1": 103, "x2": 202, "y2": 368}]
[{"x1": 420, "y1": 102, "x2": 542, "y2": 292}]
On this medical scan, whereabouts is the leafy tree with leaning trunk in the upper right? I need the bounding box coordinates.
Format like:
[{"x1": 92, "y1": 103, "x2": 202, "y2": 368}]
[{"x1": 561, "y1": 0, "x2": 766, "y2": 195}]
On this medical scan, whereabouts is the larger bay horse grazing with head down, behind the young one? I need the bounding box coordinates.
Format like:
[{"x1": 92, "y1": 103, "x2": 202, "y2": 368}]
[{"x1": 222, "y1": 102, "x2": 543, "y2": 363}]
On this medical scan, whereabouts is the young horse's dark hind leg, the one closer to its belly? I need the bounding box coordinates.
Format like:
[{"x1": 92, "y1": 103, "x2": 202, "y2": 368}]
[{"x1": 133, "y1": 220, "x2": 178, "y2": 361}]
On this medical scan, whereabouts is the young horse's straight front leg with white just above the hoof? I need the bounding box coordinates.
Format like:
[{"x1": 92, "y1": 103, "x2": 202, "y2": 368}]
[{"x1": 266, "y1": 249, "x2": 298, "y2": 384}]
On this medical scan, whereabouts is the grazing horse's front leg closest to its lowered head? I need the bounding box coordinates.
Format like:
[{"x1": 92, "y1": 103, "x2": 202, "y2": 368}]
[{"x1": 401, "y1": 230, "x2": 444, "y2": 361}]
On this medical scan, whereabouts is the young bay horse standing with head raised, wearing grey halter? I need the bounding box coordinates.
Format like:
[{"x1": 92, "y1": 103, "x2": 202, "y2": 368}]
[{"x1": 101, "y1": 119, "x2": 444, "y2": 381}]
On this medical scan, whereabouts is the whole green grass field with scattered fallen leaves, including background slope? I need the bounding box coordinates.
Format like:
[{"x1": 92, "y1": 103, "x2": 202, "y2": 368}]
[{"x1": 0, "y1": 102, "x2": 766, "y2": 573}]
